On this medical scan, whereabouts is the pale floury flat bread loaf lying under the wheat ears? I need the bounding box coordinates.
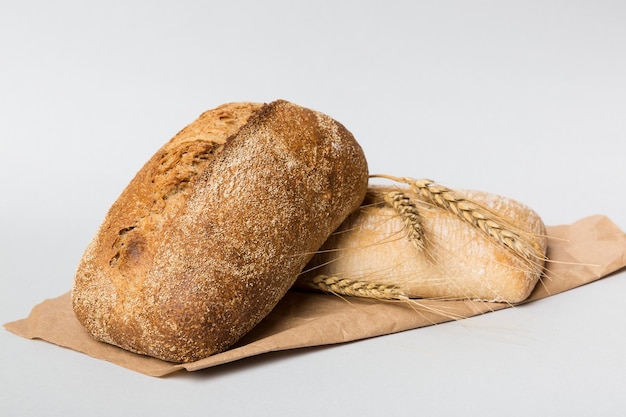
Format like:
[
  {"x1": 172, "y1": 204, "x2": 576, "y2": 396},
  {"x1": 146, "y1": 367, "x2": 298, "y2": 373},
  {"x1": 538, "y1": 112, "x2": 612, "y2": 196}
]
[{"x1": 297, "y1": 187, "x2": 547, "y2": 303}]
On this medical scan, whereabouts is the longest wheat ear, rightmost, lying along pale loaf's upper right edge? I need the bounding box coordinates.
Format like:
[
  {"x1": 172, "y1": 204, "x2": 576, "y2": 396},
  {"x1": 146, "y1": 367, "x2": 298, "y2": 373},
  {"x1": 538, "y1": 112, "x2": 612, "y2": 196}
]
[{"x1": 371, "y1": 175, "x2": 544, "y2": 262}]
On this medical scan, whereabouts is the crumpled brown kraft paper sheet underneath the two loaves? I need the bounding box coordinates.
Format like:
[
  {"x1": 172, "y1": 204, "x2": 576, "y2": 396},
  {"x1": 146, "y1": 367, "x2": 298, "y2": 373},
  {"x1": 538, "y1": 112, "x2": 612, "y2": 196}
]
[{"x1": 5, "y1": 216, "x2": 626, "y2": 376}]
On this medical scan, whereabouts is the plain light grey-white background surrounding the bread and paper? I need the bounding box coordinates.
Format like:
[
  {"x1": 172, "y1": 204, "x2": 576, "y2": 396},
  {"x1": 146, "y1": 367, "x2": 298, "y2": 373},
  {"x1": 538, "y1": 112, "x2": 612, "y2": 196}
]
[{"x1": 0, "y1": 0, "x2": 626, "y2": 416}]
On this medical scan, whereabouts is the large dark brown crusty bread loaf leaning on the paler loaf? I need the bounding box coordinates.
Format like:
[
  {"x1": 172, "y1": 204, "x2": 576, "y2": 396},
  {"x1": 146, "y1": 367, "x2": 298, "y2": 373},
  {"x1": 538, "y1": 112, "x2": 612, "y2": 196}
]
[{"x1": 72, "y1": 101, "x2": 368, "y2": 362}]
